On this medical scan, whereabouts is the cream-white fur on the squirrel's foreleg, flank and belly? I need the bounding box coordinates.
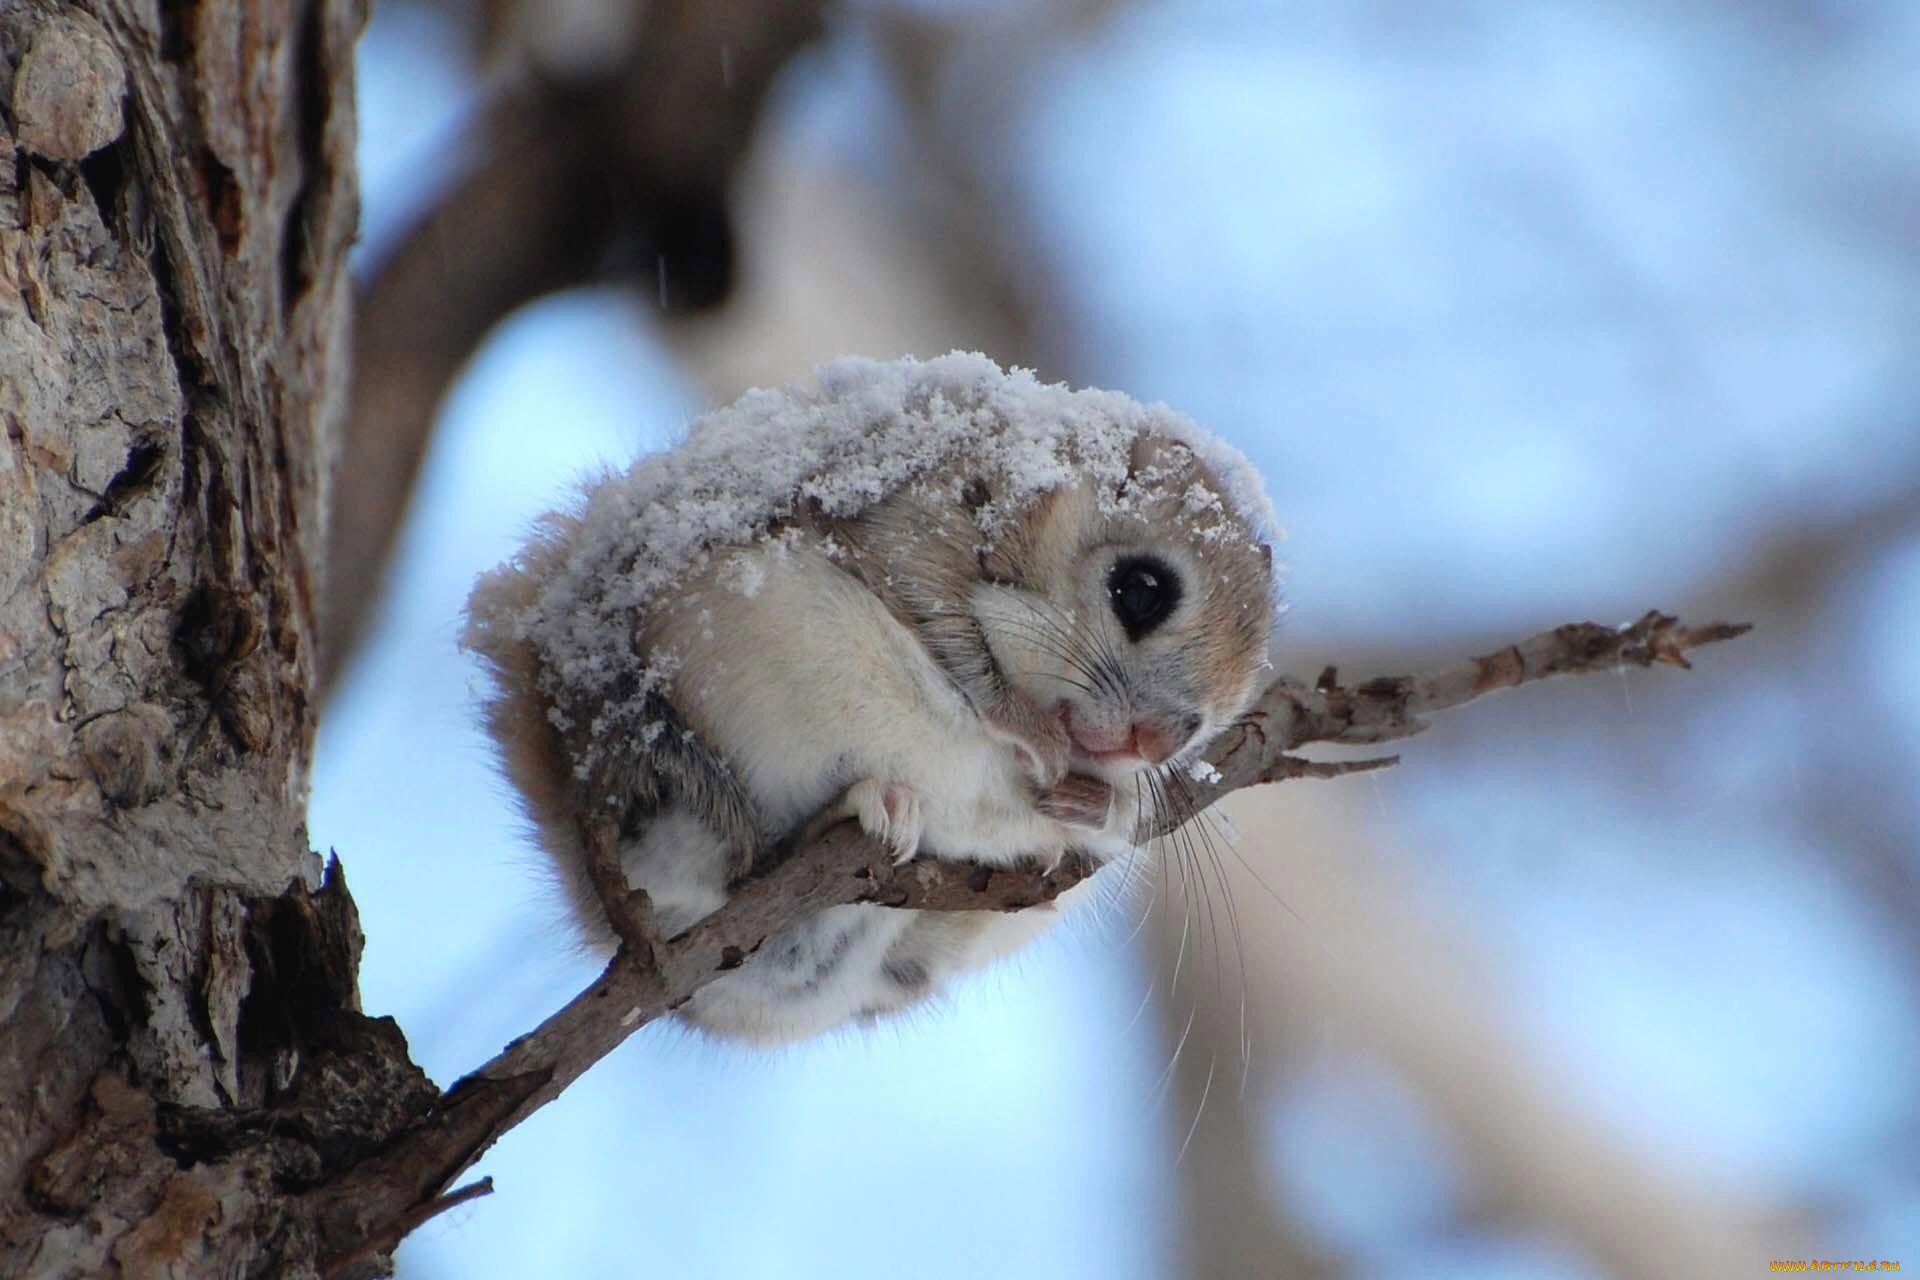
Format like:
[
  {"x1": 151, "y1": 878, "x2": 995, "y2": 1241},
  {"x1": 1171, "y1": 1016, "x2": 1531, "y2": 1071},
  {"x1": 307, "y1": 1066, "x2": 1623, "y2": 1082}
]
[{"x1": 622, "y1": 537, "x2": 1135, "y2": 1042}]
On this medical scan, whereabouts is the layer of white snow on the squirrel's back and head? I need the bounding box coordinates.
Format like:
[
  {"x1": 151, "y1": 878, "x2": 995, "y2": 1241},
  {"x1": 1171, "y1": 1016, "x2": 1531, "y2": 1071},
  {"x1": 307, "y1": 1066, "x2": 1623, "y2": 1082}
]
[{"x1": 465, "y1": 351, "x2": 1279, "y2": 731}]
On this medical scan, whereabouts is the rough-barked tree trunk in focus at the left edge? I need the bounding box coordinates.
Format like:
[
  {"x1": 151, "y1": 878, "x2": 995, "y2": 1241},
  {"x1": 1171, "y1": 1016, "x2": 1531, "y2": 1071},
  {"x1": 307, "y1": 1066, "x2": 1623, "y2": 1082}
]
[{"x1": 0, "y1": 0, "x2": 416, "y2": 1276}]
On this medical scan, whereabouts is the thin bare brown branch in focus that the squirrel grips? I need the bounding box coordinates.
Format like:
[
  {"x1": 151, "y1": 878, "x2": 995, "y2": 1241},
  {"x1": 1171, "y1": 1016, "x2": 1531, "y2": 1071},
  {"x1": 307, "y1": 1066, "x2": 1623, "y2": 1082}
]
[{"x1": 313, "y1": 612, "x2": 1747, "y2": 1253}]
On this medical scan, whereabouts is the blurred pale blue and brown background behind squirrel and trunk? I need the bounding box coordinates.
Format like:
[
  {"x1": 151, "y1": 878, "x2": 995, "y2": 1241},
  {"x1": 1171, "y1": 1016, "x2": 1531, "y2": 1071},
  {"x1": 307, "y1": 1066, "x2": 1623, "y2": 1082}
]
[{"x1": 311, "y1": 0, "x2": 1920, "y2": 1280}]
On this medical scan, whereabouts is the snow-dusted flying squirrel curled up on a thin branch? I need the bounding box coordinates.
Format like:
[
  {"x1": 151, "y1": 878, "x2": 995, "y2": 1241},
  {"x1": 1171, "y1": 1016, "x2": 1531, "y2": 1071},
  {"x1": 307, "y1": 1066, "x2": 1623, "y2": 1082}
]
[{"x1": 463, "y1": 353, "x2": 1277, "y2": 1044}]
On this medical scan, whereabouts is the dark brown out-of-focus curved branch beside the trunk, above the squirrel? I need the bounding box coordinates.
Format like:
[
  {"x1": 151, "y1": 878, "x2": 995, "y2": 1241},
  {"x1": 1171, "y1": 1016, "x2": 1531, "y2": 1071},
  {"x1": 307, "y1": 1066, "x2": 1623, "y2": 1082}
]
[{"x1": 321, "y1": 0, "x2": 822, "y2": 695}]
